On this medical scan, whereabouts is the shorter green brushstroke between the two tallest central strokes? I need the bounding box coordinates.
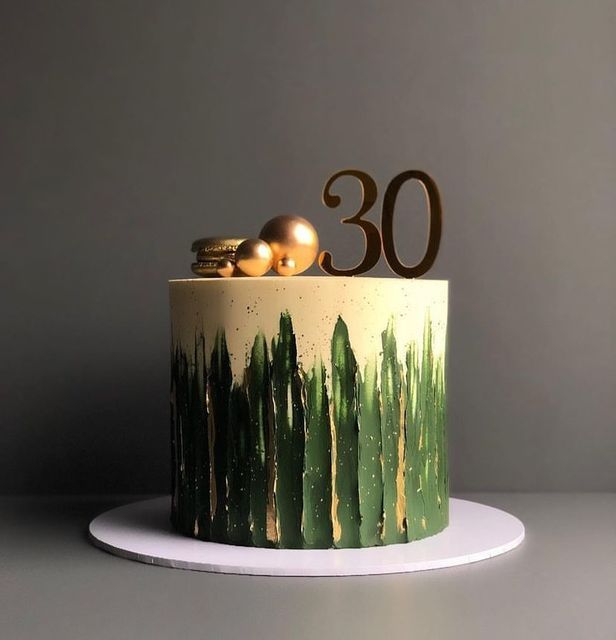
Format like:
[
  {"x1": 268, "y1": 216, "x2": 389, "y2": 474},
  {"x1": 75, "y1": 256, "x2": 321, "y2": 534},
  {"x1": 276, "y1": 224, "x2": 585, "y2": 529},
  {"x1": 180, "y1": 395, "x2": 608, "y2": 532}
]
[{"x1": 303, "y1": 361, "x2": 333, "y2": 549}]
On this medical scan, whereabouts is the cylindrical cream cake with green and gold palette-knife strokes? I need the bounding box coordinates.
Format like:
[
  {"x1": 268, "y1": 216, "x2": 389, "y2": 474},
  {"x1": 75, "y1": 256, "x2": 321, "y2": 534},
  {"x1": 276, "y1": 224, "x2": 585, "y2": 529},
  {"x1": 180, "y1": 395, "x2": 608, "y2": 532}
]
[{"x1": 170, "y1": 276, "x2": 449, "y2": 549}]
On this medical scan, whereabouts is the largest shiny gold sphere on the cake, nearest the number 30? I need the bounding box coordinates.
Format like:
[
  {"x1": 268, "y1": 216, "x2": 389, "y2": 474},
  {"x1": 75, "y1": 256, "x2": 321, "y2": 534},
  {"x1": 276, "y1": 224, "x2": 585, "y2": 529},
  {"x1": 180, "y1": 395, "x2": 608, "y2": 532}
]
[{"x1": 259, "y1": 216, "x2": 319, "y2": 275}]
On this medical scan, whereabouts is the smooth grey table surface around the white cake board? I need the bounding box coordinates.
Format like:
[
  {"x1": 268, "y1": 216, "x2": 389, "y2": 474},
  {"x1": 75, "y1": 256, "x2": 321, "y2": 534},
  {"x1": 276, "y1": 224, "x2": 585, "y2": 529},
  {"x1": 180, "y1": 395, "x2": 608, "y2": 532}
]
[{"x1": 0, "y1": 493, "x2": 616, "y2": 640}]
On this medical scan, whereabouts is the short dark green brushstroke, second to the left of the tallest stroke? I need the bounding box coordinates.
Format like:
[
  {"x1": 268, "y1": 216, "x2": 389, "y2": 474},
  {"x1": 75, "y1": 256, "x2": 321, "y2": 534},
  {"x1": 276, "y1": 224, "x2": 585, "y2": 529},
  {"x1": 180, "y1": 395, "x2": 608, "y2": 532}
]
[{"x1": 227, "y1": 384, "x2": 252, "y2": 546}]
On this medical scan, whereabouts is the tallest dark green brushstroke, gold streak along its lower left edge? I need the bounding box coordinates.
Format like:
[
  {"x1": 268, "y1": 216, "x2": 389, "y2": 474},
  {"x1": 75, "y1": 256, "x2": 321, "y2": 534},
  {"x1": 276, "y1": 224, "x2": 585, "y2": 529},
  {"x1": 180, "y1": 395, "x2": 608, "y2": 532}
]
[{"x1": 272, "y1": 313, "x2": 304, "y2": 549}]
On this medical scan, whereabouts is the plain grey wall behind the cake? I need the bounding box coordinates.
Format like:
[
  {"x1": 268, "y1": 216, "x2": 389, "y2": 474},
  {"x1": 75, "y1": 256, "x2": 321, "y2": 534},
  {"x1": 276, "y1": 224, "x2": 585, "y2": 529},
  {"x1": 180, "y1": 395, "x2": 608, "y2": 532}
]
[{"x1": 0, "y1": 0, "x2": 616, "y2": 493}]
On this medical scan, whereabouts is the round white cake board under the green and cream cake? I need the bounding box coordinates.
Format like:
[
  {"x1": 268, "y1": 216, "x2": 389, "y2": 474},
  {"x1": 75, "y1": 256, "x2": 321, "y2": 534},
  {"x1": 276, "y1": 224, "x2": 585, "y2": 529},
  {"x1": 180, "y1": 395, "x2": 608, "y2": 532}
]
[{"x1": 90, "y1": 497, "x2": 524, "y2": 576}]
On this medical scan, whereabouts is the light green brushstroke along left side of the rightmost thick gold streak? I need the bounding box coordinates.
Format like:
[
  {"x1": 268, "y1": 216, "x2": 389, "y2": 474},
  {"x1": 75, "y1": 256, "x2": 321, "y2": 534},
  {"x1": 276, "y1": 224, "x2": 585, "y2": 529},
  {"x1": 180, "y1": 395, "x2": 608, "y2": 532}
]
[{"x1": 381, "y1": 319, "x2": 406, "y2": 544}]
